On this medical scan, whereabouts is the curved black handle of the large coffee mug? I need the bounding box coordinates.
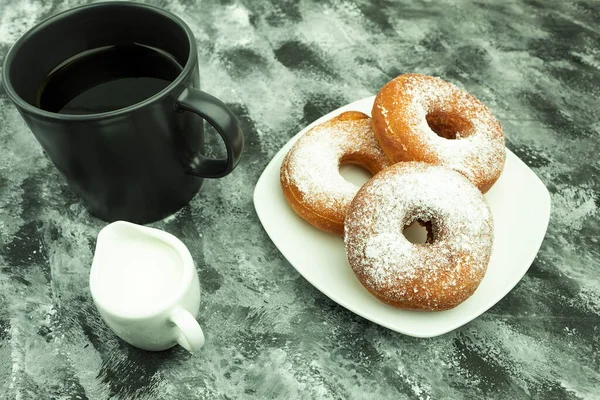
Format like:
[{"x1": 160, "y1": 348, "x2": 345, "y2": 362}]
[{"x1": 175, "y1": 86, "x2": 244, "y2": 178}]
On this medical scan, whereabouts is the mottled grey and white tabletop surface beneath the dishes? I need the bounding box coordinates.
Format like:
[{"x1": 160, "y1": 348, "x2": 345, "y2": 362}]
[{"x1": 0, "y1": 0, "x2": 600, "y2": 399}]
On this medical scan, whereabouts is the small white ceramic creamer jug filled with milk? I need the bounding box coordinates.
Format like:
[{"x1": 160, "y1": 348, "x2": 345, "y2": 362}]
[{"x1": 90, "y1": 221, "x2": 204, "y2": 353}]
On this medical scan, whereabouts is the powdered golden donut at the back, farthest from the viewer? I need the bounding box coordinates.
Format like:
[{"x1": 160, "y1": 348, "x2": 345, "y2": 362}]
[{"x1": 372, "y1": 74, "x2": 506, "y2": 193}]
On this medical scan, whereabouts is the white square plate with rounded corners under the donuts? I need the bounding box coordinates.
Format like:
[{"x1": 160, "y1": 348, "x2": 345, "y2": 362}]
[{"x1": 254, "y1": 97, "x2": 550, "y2": 337}]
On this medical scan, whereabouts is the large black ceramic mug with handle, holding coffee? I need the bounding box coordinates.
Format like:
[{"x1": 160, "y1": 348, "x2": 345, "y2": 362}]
[{"x1": 3, "y1": 2, "x2": 244, "y2": 223}]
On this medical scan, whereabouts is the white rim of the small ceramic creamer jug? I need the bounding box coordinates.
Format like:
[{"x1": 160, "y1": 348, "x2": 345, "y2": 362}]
[{"x1": 89, "y1": 220, "x2": 199, "y2": 321}]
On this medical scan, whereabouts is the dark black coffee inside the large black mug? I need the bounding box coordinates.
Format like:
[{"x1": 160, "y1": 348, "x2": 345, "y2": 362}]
[{"x1": 37, "y1": 44, "x2": 182, "y2": 115}]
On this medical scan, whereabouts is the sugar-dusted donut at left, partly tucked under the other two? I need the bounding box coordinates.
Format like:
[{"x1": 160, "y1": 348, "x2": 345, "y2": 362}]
[{"x1": 280, "y1": 111, "x2": 391, "y2": 236}]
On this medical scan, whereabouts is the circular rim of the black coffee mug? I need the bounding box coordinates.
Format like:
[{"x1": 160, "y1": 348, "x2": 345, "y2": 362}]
[{"x1": 2, "y1": 1, "x2": 196, "y2": 121}]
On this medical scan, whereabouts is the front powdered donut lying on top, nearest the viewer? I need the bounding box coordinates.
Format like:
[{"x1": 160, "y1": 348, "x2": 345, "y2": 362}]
[{"x1": 344, "y1": 162, "x2": 493, "y2": 311}]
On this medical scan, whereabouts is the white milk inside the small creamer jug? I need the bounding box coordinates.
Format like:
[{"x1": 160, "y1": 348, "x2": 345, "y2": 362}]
[{"x1": 93, "y1": 234, "x2": 183, "y2": 313}]
